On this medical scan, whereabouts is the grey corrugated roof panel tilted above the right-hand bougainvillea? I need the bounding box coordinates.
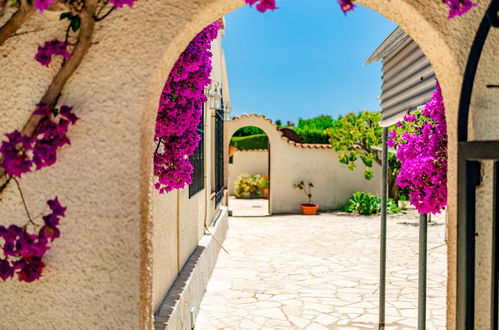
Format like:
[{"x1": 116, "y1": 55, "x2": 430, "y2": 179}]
[{"x1": 368, "y1": 28, "x2": 435, "y2": 126}]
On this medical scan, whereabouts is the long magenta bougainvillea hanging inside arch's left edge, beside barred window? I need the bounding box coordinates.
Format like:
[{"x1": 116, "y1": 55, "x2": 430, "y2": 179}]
[{"x1": 154, "y1": 21, "x2": 221, "y2": 193}]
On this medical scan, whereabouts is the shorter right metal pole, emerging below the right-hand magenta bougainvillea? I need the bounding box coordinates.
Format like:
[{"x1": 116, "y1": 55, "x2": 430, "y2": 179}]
[{"x1": 418, "y1": 213, "x2": 428, "y2": 330}]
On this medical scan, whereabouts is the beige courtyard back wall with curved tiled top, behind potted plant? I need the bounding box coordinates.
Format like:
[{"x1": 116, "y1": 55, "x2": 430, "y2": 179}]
[{"x1": 226, "y1": 115, "x2": 381, "y2": 213}]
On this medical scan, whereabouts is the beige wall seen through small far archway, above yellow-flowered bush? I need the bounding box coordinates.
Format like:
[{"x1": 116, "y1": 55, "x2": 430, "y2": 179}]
[{"x1": 227, "y1": 150, "x2": 269, "y2": 195}]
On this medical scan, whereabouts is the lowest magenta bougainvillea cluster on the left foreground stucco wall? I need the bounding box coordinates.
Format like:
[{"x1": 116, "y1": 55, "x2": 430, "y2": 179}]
[{"x1": 0, "y1": 197, "x2": 66, "y2": 282}]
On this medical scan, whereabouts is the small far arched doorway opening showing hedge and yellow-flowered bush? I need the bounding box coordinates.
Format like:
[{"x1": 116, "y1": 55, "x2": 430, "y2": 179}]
[{"x1": 227, "y1": 126, "x2": 271, "y2": 217}]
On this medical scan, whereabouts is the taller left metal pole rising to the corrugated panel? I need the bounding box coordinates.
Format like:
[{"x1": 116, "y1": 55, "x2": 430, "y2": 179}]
[{"x1": 378, "y1": 127, "x2": 388, "y2": 329}]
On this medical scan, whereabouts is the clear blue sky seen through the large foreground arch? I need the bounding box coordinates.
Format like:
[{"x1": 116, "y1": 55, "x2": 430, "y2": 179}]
[{"x1": 223, "y1": 0, "x2": 396, "y2": 121}]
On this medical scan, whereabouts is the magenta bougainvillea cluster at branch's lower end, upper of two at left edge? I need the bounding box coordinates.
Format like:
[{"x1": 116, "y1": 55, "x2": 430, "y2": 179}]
[{"x1": 0, "y1": 103, "x2": 78, "y2": 177}]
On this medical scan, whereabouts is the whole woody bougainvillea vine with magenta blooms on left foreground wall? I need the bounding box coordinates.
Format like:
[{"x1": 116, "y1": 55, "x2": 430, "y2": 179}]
[{"x1": 0, "y1": 0, "x2": 136, "y2": 282}]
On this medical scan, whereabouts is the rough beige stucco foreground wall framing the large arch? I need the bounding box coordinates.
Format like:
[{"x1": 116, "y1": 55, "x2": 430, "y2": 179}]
[{"x1": 0, "y1": 0, "x2": 499, "y2": 329}]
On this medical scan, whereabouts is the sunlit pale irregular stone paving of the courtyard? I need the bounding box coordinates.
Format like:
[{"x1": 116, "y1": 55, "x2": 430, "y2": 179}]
[{"x1": 196, "y1": 210, "x2": 447, "y2": 330}]
